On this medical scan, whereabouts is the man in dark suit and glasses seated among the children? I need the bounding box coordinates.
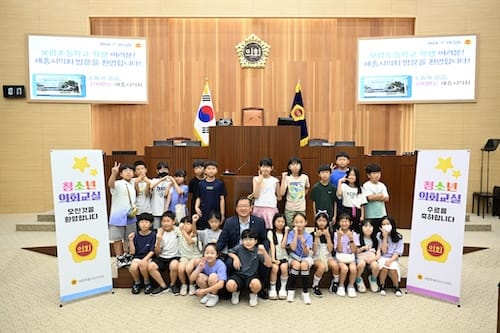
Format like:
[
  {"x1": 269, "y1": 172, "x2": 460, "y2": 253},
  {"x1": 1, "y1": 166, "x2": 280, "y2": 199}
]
[{"x1": 217, "y1": 197, "x2": 270, "y2": 298}]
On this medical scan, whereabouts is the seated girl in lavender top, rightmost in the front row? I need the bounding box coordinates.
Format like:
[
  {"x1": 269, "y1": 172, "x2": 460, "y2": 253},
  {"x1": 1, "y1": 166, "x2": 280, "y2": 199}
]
[{"x1": 377, "y1": 216, "x2": 404, "y2": 297}]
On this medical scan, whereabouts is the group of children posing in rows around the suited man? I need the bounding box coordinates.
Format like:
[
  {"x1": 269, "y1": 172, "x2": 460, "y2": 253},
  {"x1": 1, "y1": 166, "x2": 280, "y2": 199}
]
[{"x1": 108, "y1": 153, "x2": 403, "y2": 307}]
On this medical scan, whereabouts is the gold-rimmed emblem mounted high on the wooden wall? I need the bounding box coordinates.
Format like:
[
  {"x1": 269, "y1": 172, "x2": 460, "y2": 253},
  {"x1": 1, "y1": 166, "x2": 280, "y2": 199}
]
[{"x1": 236, "y1": 34, "x2": 271, "y2": 68}]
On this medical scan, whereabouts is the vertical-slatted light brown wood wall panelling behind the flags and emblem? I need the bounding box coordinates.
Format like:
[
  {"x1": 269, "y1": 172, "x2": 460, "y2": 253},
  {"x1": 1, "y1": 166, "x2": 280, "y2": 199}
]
[{"x1": 90, "y1": 17, "x2": 414, "y2": 157}]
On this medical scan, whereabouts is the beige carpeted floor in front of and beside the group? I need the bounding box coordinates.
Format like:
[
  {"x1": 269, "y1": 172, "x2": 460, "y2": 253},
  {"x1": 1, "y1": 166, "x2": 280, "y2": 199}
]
[{"x1": 0, "y1": 214, "x2": 500, "y2": 333}]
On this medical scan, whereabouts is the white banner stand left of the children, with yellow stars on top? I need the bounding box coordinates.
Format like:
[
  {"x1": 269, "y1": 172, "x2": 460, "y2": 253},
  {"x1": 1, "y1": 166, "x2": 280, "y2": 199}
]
[{"x1": 50, "y1": 150, "x2": 113, "y2": 307}]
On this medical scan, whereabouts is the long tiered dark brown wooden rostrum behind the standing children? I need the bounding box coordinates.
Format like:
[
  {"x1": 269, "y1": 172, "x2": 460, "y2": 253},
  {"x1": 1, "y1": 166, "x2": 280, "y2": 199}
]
[{"x1": 105, "y1": 126, "x2": 416, "y2": 229}]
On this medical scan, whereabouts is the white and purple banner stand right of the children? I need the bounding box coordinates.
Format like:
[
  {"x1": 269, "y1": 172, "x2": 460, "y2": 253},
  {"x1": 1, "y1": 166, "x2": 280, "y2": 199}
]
[{"x1": 406, "y1": 150, "x2": 470, "y2": 307}]
